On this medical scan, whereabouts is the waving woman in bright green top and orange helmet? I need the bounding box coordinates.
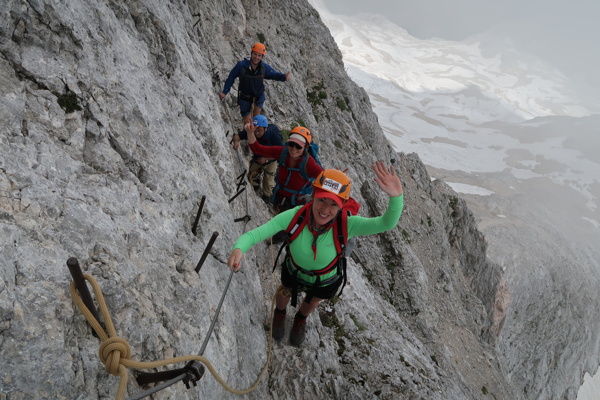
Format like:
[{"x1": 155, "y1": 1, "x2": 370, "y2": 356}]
[{"x1": 227, "y1": 161, "x2": 404, "y2": 346}]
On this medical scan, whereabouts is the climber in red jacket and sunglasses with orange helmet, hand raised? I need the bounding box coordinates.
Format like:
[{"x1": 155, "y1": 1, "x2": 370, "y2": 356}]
[{"x1": 245, "y1": 124, "x2": 323, "y2": 213}]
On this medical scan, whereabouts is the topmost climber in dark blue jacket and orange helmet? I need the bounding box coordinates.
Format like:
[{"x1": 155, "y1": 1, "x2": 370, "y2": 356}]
[{"x1": 219, "y1": 43, "x2": 290, "y2": 125}]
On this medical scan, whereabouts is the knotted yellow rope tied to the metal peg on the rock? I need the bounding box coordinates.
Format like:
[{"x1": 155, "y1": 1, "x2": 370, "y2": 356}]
[{"x1": 70, "y1": 274, "x2": 277, "y2": 400}]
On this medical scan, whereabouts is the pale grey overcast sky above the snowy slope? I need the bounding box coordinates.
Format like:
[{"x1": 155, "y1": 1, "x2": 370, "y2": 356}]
[{"x1": 322, "y1": 0, "x2": 600, "y2": 103}]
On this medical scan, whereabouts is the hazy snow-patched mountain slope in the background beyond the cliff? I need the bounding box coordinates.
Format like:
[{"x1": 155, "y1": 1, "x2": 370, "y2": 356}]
[{"x1": 310, "y1": 2, "x2": 600, "y2": 398}]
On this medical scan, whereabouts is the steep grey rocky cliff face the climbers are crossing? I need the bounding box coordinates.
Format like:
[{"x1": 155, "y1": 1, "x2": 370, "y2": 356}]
[{"x1": 0, "y1": 0, "x2": 510, "y2": 399}]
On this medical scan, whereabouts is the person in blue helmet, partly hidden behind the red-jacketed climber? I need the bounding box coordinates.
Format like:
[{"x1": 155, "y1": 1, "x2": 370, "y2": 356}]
[{"x1": 233, "y1": 115, "x2": 283, "y2": 203}]
